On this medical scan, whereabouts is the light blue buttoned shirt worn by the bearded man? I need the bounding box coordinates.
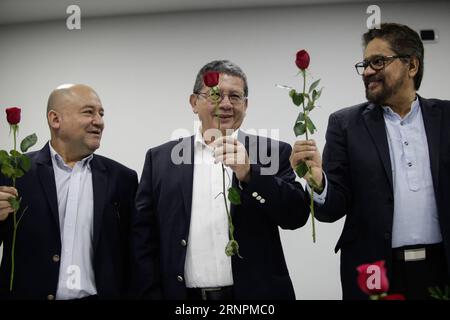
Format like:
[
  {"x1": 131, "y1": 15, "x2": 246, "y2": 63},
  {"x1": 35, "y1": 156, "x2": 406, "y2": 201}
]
[{"x1": 307, "y1": 98, "x2": 442, "y2": 248}]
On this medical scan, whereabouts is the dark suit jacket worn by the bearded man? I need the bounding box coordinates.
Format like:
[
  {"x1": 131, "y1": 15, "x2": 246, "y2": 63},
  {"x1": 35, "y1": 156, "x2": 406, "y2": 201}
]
[{"x1": 316, "y1": 97, "x2": 450, "y2": 299}]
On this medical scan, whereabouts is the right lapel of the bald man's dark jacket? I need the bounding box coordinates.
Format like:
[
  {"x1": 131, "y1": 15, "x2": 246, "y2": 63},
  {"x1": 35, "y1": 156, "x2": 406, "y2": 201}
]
[{"x1": 91, "y1": 154, "x2": 108, "y2": 252}]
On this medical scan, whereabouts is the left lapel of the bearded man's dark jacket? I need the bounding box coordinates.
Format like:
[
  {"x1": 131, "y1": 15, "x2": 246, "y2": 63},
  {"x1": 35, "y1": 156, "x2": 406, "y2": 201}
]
[{"x1": 363, "y1": 103, "x2": 393, "y2": 192}]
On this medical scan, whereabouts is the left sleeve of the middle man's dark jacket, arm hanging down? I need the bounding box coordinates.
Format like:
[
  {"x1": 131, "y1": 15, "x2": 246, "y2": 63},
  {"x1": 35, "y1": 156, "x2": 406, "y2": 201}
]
[{"x1": 131, "y1": 150, "x2": 162, "y2": 299}]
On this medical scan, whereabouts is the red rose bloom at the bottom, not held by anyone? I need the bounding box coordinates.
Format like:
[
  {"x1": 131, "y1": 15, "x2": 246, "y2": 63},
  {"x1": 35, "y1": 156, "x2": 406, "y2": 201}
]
[{"x1": 356, "y1": 261, "x2": 389, "y2": 295}]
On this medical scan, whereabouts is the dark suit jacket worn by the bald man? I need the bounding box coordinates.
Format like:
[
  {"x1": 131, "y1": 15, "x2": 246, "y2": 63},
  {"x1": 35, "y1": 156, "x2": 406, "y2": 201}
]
[{"x1": 0, "y1": 144, "x2": 137, "y2": 299}]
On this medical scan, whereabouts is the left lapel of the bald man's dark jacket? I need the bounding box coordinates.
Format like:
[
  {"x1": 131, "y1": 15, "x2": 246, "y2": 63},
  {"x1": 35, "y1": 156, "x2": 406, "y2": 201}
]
[{"x1": 36, "y1": 142, "x2": 60, "y2": 233}]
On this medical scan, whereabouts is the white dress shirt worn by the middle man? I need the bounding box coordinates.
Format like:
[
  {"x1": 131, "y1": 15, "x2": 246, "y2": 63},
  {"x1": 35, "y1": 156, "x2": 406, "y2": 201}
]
[{"x1": 184, "y1": 128, "x2": 238, "y2": 288}]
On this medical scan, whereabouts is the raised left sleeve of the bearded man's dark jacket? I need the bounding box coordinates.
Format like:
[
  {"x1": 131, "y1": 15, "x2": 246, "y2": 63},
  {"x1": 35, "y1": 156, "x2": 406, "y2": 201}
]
[{"x1": 315, "y1": 114, "x2": 350, "y2": 222}]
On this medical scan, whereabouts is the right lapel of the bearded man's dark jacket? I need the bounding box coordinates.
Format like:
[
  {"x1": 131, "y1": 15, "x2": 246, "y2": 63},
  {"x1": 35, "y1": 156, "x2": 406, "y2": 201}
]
[{"x1": 419, "y1": 96, "x2": 441, "y2": 193}]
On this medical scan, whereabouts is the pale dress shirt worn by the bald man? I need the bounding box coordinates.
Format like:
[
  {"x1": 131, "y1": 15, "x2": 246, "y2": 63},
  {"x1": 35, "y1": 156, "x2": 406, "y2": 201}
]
[{"x1": 49, "y1": 143, "x2": 97, "y2": 300}]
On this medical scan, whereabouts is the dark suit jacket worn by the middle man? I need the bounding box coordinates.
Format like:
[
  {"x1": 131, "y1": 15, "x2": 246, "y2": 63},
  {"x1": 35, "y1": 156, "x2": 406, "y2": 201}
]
[{"x1": 132, "y1": 132, "x2": 309, "y2": 300}]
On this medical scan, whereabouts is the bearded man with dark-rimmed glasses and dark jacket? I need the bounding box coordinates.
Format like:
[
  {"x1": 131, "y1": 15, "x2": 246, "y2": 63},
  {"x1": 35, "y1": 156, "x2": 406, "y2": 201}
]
[{"x1": 291, "y1": 23, "x2": 450, "y2": 299}]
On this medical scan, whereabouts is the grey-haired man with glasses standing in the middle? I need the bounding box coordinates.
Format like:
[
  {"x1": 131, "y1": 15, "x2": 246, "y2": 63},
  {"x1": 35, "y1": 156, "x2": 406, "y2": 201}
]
[{"x1": 133, "y1": 60, "x2": 309, "y2": 300}]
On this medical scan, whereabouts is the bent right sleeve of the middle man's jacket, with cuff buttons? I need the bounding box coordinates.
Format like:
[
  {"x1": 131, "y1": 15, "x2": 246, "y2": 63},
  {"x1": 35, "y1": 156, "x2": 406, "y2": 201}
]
[{"x1": 241, "y1": 142, "x2": 309, "y2": 229}]
